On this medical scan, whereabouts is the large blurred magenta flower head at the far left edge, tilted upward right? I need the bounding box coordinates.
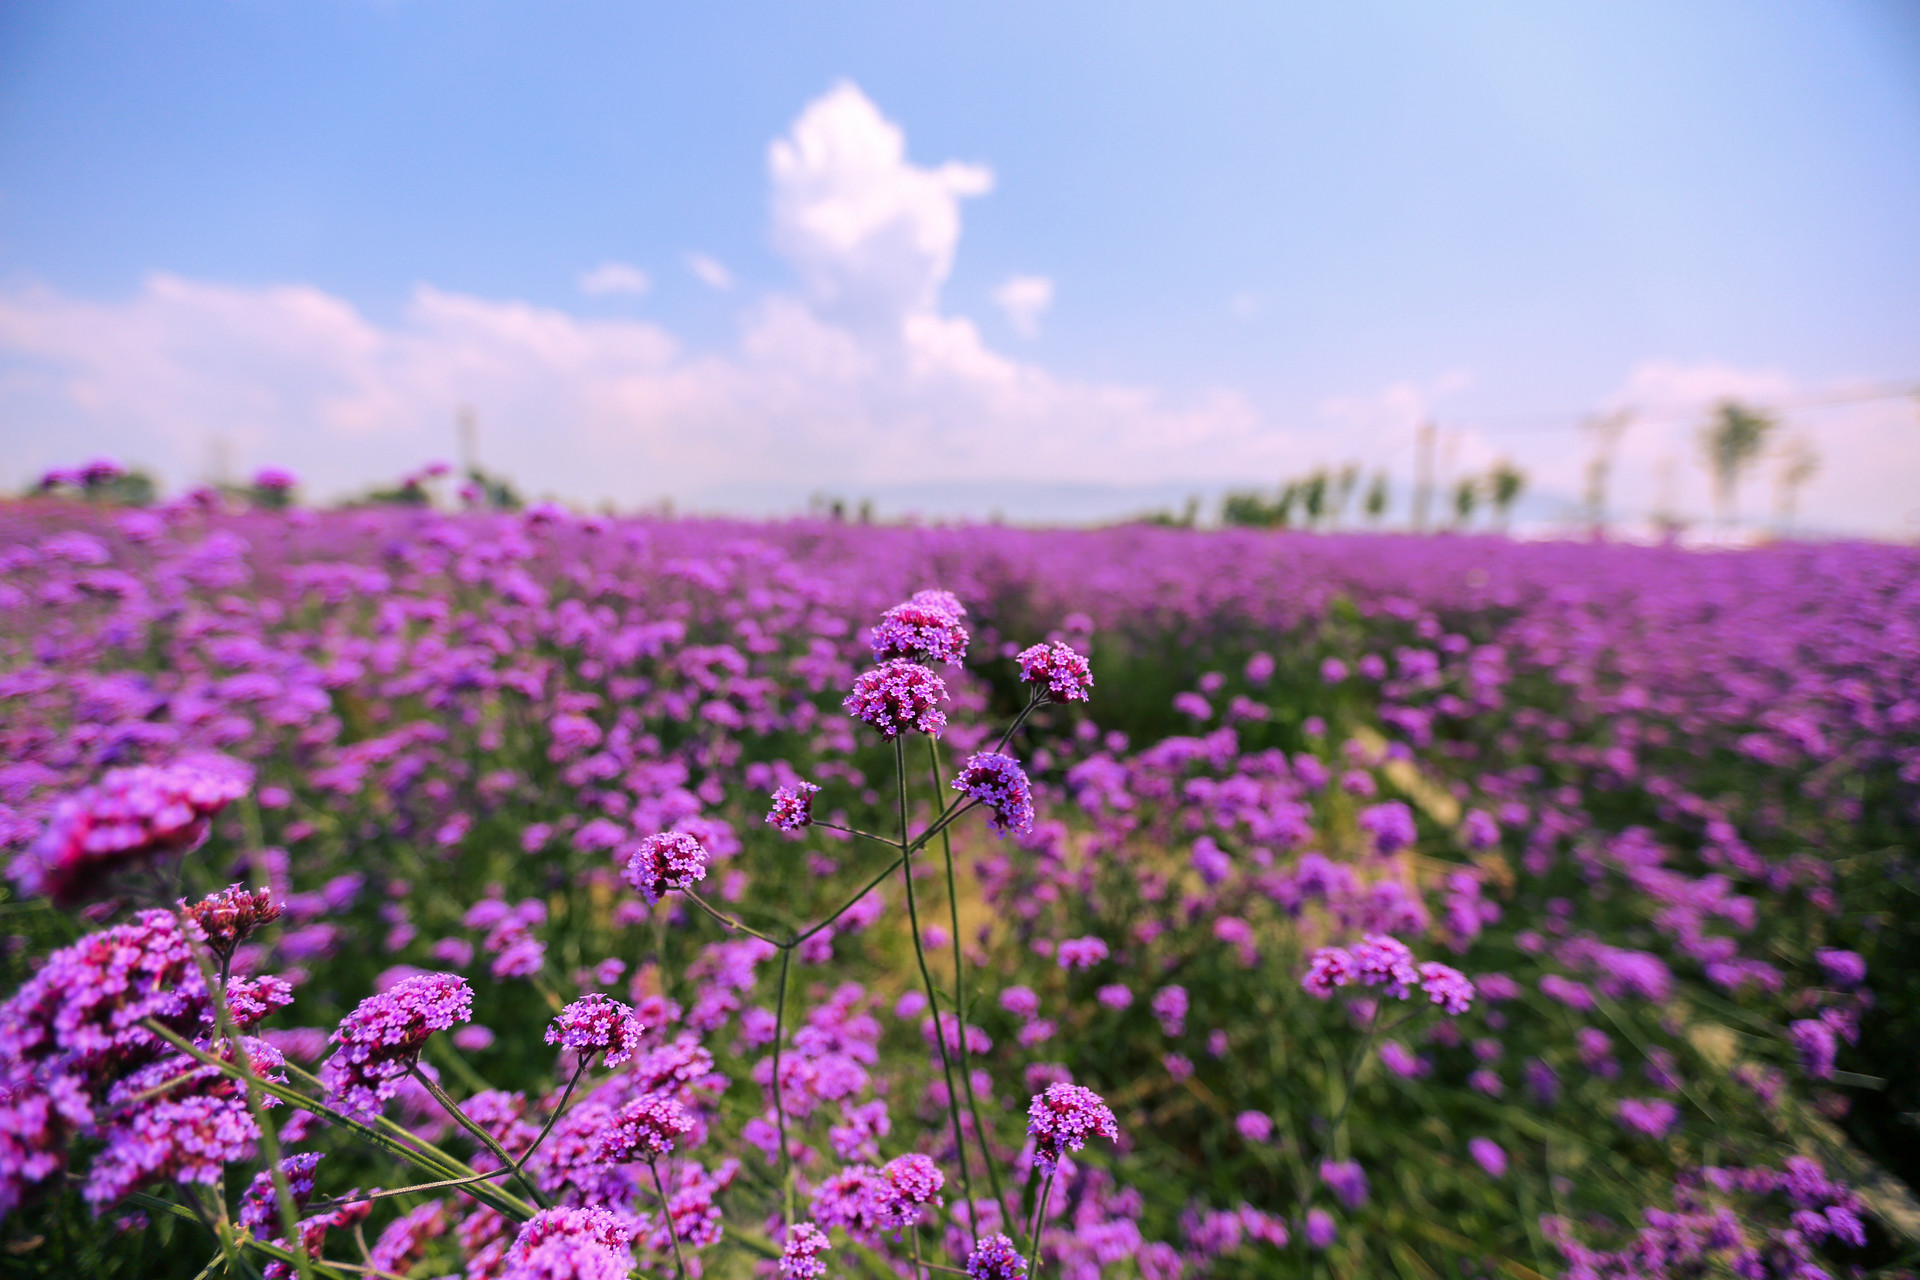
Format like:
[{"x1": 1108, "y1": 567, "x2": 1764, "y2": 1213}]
[{"x1": 8, "y1": 756, "x2": 253, "y2": 906}]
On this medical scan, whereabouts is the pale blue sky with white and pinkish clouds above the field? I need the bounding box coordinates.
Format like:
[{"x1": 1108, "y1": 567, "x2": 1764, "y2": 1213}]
[{"x1": 0, "y1": 0, "x2": 1920, "y2": 535}]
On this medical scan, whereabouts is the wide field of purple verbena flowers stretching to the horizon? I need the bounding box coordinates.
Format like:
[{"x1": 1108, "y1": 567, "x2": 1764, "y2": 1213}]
[{"x1": 0, "y1": 501, "x2": 1920, "y2": 1280}]
